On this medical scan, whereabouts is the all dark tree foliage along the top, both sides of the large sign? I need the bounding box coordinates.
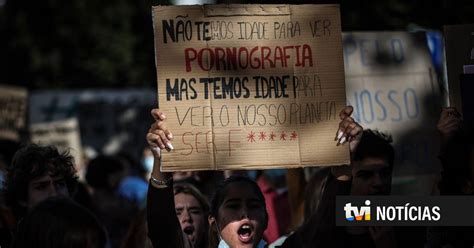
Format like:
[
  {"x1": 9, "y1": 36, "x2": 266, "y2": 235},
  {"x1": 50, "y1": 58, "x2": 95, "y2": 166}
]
[{"x1": 0, "y1": 0, "x2": 474, "y2": 88}]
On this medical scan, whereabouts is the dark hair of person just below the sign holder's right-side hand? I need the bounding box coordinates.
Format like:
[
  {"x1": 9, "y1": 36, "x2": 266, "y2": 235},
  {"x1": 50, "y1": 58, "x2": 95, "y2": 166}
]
[{"x1": 352, "y1": 129, "x2": 395, "y2": 167}]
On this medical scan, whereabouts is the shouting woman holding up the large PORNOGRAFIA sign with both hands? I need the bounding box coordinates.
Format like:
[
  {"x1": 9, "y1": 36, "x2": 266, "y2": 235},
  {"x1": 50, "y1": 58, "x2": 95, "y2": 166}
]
[{"x1": 147, "y1": 107, "x2": 362, "y2": 248}]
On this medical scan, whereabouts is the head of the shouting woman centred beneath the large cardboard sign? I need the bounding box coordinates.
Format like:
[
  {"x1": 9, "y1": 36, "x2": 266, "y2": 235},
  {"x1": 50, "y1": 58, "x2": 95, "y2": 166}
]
[{"x1": 209, "y1": 178, "x2": 268, "y2": 247}]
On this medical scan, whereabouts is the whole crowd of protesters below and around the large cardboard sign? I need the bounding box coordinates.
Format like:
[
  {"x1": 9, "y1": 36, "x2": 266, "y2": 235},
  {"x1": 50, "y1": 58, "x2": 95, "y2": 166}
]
[{"x1": 0, "y1": 106, "x2": 474, "y2": 248}]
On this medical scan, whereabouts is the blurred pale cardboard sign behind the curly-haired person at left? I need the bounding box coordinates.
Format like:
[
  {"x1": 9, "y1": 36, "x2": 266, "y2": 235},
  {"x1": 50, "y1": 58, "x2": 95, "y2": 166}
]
[{"x1": 30, "y1": 118, "x2": 84, "y2": 176}]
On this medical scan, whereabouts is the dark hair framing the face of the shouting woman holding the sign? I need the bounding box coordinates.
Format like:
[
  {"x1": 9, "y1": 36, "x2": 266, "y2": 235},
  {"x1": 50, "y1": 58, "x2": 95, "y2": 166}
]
[{"x1": 209, "y1": 176, "x2": 268, "y2": 247}]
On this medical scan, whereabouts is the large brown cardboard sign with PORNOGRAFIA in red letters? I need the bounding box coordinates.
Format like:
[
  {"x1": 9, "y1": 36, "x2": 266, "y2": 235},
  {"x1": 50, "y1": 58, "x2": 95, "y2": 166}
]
[{"x1": 153, "y1": 5, "x2": 349, "y2": 171}]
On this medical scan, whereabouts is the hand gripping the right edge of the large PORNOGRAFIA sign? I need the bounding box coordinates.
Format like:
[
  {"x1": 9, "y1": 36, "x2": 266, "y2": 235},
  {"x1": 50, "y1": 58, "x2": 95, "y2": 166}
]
[{"x1": 334, "y1": 106, "x2": 363, "y2": 152}]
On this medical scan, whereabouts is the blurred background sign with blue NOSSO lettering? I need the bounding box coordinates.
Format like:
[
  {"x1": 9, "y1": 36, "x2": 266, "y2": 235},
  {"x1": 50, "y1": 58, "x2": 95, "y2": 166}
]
[{"x1": 343, "y1": 32, "x2": 441, "y2": 184}]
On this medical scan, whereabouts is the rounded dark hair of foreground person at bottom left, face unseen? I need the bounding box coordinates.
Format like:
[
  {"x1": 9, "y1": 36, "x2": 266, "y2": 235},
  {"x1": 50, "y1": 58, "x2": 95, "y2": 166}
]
[{"x1": 12, "y1": 197, "x2": 107, "y2": 248}]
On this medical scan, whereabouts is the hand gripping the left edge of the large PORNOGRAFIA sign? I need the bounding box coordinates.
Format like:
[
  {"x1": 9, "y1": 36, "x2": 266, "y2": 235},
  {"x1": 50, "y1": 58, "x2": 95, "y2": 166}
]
[{"x1": 146, "y1": 109, "x2": 173, "y2": 158}]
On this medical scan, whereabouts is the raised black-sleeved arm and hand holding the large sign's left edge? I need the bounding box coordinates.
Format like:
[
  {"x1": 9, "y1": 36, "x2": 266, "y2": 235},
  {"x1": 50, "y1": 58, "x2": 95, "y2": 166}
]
[{"x1": 146, "y1": 109, "x2": 185, "y2": 248}]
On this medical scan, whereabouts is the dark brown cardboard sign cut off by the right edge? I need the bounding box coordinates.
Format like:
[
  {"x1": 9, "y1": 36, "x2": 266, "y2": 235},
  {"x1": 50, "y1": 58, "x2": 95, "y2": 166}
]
[{"x1": 443, "y1": 24, "x2": 474, "y2": 113}]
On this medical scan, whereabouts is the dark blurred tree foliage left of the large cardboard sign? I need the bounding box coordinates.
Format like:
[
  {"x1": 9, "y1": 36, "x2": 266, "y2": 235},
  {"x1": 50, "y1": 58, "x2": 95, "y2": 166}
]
[{"x1": 0, "y1": 0, "x2": 170, "y2": 88}]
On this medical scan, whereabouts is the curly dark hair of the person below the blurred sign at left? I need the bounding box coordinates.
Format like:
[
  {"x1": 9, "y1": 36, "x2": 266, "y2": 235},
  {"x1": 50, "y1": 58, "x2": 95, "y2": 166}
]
[{"x1": 4, "y1": 144, "x2": 77, "y2": 217}]
